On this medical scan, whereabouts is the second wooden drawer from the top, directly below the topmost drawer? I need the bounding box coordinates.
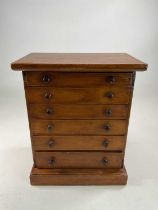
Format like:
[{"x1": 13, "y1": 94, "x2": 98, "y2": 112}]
[{"x1": 26, "y1": 87, "x2": 133, "y2": 104}]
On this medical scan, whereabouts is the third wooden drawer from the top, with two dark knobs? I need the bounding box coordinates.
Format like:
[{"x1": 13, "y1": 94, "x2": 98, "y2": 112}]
[{"x1": 29, "y1": 104, "x2": 129, "y2": 119}]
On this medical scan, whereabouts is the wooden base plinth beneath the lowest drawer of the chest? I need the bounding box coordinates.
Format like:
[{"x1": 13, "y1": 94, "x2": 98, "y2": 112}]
[{"x1": 30, "y1": 167, "x2": 128, "y2": 185}]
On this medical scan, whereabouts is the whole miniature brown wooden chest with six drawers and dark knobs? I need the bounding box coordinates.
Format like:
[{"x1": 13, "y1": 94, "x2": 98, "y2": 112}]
[{"x1": 11, "y1": 53, "x2": 147, "y2": 185}]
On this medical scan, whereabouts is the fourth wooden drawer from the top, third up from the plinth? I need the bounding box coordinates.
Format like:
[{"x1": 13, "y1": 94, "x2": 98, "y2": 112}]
[{"x1": 31, "y1": 120, "x2": 127, "y2": 135}]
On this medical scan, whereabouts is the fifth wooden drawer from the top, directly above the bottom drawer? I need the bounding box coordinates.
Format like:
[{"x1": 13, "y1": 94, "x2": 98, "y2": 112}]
[{"x1": 32, "y1": 136, "x2": 126, "y2": 151}]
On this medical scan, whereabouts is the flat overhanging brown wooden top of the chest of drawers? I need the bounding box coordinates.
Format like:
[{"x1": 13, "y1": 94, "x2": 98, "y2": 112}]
[{"x1": 11, "y1": 53, "x2": 147, "y2": 72}]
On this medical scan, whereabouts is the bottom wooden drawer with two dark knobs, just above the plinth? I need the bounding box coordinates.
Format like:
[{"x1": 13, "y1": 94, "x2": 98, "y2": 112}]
[{"x1": 35, "y1": 152, "x2": 123, "y2": 168}]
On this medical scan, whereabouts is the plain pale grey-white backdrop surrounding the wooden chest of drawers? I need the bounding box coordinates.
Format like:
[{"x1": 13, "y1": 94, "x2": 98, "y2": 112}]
[{"x1": 0, "y1": 0, "x2": 158, "y2": 210}]
